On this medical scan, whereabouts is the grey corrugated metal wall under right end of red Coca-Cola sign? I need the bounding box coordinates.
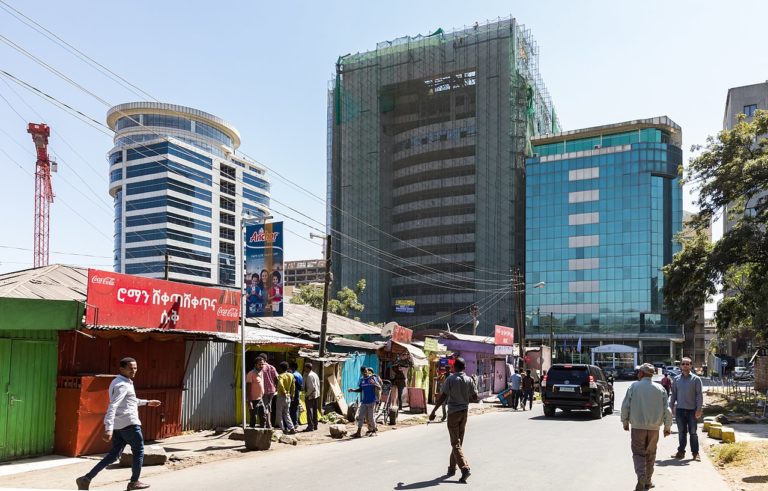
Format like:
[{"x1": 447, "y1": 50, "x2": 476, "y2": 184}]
[{"x1": 181, "y1": 341, "x2": 236, "y2": 431}]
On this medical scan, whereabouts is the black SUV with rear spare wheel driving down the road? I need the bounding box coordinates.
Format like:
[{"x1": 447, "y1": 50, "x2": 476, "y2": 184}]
[{"x1": 541, "y1": 363, "x2": 614, "y2": 419}]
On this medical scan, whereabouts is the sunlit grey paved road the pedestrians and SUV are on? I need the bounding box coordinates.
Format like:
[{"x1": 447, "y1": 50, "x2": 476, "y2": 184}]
[{"x1": 84, "y1": 382, "x2": 727, "y2": 491}]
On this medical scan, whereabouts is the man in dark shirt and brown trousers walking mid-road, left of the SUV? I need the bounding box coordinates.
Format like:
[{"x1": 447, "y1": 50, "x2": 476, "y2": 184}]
[{"x1": 429, "y1": 356, "x2": 477, "y2": 484}]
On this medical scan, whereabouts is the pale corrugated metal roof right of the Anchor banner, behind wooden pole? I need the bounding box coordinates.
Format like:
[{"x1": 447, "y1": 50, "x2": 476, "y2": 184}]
[{"x1": 248, "y1": 302, "x2": 381, "y2": 336}]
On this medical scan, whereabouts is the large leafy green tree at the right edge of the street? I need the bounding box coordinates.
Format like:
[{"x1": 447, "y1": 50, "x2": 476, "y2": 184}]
[{"x1": 664, "y1": 111, "x2": 768, "y2": 341}]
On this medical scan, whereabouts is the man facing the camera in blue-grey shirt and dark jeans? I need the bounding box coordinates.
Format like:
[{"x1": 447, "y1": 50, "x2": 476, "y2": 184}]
[{"x1": 669, "y1": 357, "x2": 704, "y2": 462}]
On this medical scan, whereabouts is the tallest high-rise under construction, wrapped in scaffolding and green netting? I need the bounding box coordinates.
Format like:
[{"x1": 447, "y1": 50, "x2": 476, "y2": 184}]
[{"x1": 328, "y1": 18, "x2": 559, "y2": 333}]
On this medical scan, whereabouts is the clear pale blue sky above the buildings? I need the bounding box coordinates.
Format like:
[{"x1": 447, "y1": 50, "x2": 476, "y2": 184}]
[{"x1": 0, "y1": 0, "x2": 768, "y2": 272}]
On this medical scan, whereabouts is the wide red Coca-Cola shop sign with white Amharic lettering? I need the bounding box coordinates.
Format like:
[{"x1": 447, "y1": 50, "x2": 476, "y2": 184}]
[{"x1": 85, "y1": 269, "x2": 240, "y2": 333}]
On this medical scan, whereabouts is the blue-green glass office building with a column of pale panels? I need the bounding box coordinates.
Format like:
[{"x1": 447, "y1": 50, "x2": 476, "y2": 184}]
[{"x1": 525, "y1": 117, "x2": 683, "y2": 361}]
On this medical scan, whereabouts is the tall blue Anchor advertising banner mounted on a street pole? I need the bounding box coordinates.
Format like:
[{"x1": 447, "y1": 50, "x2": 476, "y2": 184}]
[{"x1": 243, "y1": 222, "x2": 283, "y2": 317}]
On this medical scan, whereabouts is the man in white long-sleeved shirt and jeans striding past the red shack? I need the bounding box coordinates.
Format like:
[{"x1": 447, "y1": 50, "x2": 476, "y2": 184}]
[{"x1": 75, "y1": 357, "x2": 161, "y2": 491}]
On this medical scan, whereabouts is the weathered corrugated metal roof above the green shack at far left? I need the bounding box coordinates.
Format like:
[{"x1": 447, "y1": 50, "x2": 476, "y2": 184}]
[{"x1": 0, "y1": 264, "x2": 88, "y2": 302}]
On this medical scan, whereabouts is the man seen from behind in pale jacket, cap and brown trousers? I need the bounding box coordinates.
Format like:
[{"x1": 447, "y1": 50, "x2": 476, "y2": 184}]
[{"x1": 621, "y1": 363, "x2": 672, "y2": 491}]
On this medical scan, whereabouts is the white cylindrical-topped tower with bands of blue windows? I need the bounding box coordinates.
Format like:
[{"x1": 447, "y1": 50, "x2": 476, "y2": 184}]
[{"x1": 107, "y1": 102, "x2": 270, "y2": 286}]
